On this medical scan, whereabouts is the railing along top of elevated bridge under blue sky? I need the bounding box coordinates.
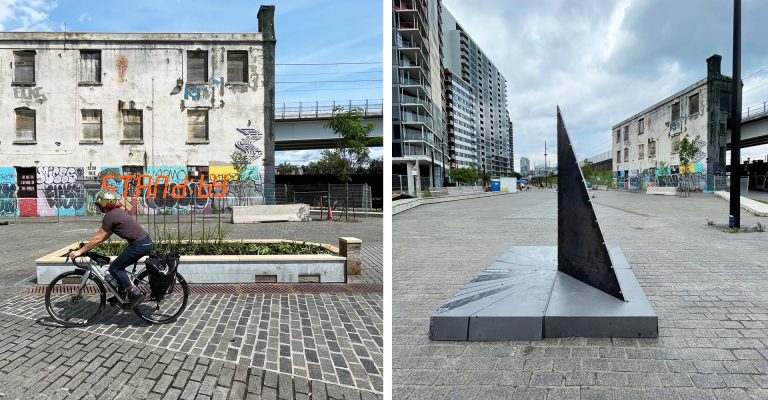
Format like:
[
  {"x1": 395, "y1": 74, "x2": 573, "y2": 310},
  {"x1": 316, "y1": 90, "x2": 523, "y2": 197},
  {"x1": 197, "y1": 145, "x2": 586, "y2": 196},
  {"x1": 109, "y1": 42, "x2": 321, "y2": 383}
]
[{"x1": 275, "y1": 99, "x2": 384, "y2": 119}]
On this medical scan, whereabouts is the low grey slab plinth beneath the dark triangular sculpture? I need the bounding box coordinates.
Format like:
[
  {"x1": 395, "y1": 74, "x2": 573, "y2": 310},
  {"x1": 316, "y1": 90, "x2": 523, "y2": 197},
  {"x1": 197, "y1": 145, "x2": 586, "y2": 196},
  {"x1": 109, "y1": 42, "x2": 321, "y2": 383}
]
[{"x1": 429, "y1": 246, "x2": 658, "y2": 341}]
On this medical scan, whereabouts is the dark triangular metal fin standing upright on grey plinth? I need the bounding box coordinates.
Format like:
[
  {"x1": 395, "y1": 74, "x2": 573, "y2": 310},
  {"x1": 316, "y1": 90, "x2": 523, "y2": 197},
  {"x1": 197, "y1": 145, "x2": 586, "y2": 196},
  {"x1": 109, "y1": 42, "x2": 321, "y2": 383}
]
[{"x1": 557, "y1": 106, "x2": 624, "y2": 300}]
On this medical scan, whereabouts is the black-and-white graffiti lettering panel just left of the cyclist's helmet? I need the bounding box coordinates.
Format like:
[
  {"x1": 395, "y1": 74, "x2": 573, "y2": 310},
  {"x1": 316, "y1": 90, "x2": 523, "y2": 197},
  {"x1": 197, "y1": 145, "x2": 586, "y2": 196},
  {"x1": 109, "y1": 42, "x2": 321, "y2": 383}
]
[{"x1": 37, "y1": 167, "x2": 86, "y2": 216}]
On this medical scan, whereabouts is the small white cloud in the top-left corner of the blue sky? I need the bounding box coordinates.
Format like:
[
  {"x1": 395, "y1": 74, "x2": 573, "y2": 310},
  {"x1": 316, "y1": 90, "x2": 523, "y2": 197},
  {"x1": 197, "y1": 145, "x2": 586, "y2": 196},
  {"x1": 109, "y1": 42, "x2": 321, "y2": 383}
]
[{"x1": 0, "y1": 0, "x2": 57, "y2": 32}]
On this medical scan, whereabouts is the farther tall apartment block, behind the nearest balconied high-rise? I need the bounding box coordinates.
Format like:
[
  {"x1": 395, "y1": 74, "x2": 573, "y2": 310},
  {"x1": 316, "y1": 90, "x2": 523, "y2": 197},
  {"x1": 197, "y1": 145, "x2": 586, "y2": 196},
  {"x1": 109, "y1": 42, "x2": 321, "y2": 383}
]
[{"x1": 442, "y1": 7, "x2": 514, "y2": 177}]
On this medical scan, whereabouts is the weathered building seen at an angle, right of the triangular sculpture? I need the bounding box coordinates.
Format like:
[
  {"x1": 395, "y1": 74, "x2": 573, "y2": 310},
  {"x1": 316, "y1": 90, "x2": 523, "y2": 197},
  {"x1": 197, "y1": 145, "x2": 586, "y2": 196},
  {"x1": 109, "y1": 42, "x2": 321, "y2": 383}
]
[{"x1": 611, "y1": 54, "x2": 731, "y2": 190}]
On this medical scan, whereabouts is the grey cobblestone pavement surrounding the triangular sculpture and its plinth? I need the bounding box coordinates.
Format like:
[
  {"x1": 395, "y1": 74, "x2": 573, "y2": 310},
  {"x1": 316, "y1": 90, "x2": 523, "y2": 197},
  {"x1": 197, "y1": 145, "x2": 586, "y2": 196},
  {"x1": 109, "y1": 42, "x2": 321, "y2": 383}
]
[{"x1": 392, "y1": 190, "x2": 768, "y2": 400}]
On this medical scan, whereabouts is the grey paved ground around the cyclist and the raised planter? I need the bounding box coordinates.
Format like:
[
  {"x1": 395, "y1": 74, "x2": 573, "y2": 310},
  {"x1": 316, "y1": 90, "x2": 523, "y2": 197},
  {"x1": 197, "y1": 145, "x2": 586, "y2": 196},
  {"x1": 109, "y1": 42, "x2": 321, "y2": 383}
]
[{"x1": 0, "y1": 217, "x2": 383, "y2": 399}]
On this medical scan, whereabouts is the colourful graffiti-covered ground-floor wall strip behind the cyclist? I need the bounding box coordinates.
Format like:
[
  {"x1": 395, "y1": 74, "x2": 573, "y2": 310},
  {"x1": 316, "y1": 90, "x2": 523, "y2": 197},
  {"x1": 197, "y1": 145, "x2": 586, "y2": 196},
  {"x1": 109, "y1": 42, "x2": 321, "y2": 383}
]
[{"x1": 0, "y1": 165, "x2": 266, "y2": 218}]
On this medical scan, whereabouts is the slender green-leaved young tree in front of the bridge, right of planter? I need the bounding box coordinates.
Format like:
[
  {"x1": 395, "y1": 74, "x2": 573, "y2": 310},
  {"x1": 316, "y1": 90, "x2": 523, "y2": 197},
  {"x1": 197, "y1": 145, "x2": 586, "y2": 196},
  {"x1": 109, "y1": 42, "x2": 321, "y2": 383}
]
[{"x1": 324, "y1": 106, "x2": 374, "y2": 220}]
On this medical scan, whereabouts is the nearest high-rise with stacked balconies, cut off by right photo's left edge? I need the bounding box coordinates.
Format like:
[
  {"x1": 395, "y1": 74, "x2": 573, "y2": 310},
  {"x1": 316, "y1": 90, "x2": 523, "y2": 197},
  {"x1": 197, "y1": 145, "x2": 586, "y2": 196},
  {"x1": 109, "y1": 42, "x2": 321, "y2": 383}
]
[{"x1": 392, "y1": 0, "x2": 449, "y2": 195}]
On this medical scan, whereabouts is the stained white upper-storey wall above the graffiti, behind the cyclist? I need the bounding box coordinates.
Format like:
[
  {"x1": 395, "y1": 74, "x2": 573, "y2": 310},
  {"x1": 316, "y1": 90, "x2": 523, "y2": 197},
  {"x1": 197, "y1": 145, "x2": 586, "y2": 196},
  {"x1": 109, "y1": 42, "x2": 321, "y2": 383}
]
[{"x1": 0, "y1": 33, "x2": 274, "y2": 167}]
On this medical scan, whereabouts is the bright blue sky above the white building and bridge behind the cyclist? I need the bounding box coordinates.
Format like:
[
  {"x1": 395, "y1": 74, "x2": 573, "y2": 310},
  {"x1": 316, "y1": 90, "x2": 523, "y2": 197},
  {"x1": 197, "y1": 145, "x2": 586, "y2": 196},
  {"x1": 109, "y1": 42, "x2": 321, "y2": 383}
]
[{"x1": 0, "y1": 0, "x2": 383, "y2": 165}]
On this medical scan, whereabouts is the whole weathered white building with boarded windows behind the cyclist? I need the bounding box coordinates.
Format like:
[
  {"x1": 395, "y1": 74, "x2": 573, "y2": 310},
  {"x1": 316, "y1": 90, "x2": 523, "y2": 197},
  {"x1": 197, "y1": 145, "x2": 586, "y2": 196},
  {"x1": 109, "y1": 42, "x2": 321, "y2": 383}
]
[{"x1": 0, "y1": 6, "x2": 276, "y2": 216}]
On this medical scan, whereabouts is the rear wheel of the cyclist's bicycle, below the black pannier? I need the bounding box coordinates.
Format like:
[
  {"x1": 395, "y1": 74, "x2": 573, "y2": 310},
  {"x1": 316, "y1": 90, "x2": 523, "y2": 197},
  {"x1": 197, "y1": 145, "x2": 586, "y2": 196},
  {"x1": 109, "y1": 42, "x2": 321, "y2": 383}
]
[{"x1": 133, "y1": 270, "x2": 189, "y2": 324}]
